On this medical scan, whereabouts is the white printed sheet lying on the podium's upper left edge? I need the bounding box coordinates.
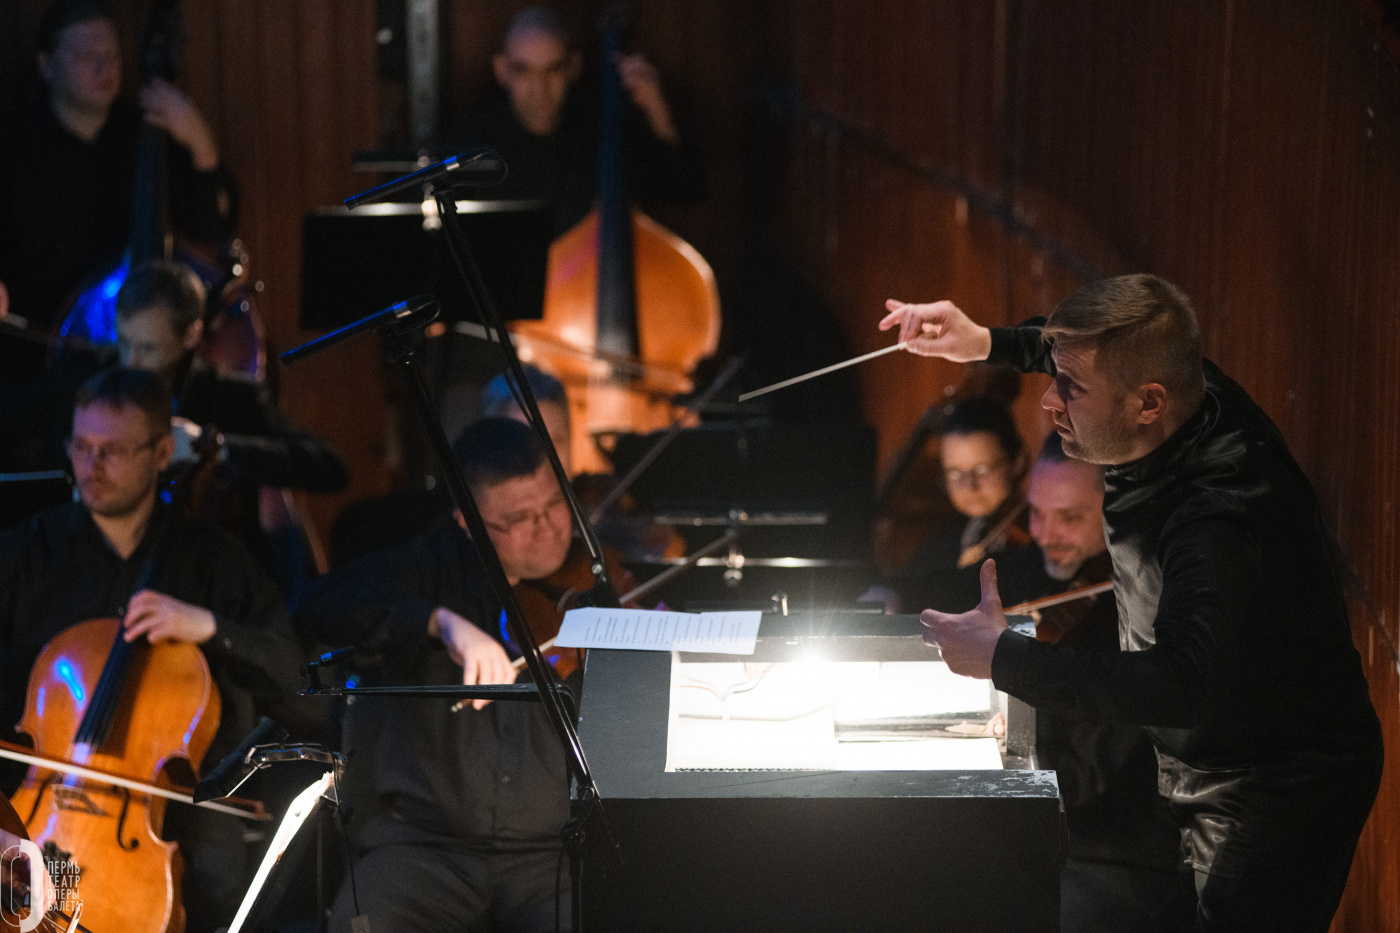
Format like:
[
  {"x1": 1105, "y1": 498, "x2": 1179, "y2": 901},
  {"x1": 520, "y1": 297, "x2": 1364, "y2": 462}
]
[{"x1": 554, "y1": 608, "x2": 762, "y2": 654}]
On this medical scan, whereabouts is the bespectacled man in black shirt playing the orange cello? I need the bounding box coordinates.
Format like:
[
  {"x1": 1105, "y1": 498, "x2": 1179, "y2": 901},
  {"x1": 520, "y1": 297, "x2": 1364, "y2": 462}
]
[{"x1": 0, "y1": 368, "x2": 300, "y2": 933}]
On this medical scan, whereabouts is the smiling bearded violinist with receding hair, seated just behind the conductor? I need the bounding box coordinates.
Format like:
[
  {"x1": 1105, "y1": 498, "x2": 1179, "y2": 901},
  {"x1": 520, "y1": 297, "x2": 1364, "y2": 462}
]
[{"x1": 1019, "y1": 433, "x2": 1180, "y2": 933}]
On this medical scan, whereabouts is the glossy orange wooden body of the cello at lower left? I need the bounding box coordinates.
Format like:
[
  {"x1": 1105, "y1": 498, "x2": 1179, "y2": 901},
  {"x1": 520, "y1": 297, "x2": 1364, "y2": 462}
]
[{"x1": 11, "y1": 619, "x2": 221, "y2": 933}]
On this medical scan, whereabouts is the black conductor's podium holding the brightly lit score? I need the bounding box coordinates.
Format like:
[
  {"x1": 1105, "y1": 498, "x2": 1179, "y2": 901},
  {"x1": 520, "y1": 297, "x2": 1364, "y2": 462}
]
[{"x1": 578, "y1": 614, "x2": 1064, "y2": 933}]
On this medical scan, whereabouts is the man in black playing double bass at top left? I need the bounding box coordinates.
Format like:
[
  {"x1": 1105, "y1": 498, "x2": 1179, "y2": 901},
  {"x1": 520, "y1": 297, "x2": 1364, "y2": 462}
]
[{"x1": 0, "y1": 0, "x2": 237, "y2": 329}]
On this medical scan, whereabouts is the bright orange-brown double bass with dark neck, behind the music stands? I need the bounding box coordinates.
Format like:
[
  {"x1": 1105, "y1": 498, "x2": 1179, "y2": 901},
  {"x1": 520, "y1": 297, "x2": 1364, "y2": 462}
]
[{"x1": 510, "y1": 4, "x2": 720, "y2": 472}]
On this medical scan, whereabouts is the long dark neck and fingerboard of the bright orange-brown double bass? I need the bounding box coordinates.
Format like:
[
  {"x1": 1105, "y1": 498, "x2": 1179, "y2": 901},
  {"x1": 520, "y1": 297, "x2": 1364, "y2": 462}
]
[{"x1": 596, "y1": 14, "x2": 638, "y2": 357}]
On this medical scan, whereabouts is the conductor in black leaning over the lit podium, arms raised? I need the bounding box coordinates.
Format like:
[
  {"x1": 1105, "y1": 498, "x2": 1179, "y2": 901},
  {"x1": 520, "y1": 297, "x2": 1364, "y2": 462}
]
[{"x1": 881, "y1": 275, "x2": 1382, "y2": 933}]
